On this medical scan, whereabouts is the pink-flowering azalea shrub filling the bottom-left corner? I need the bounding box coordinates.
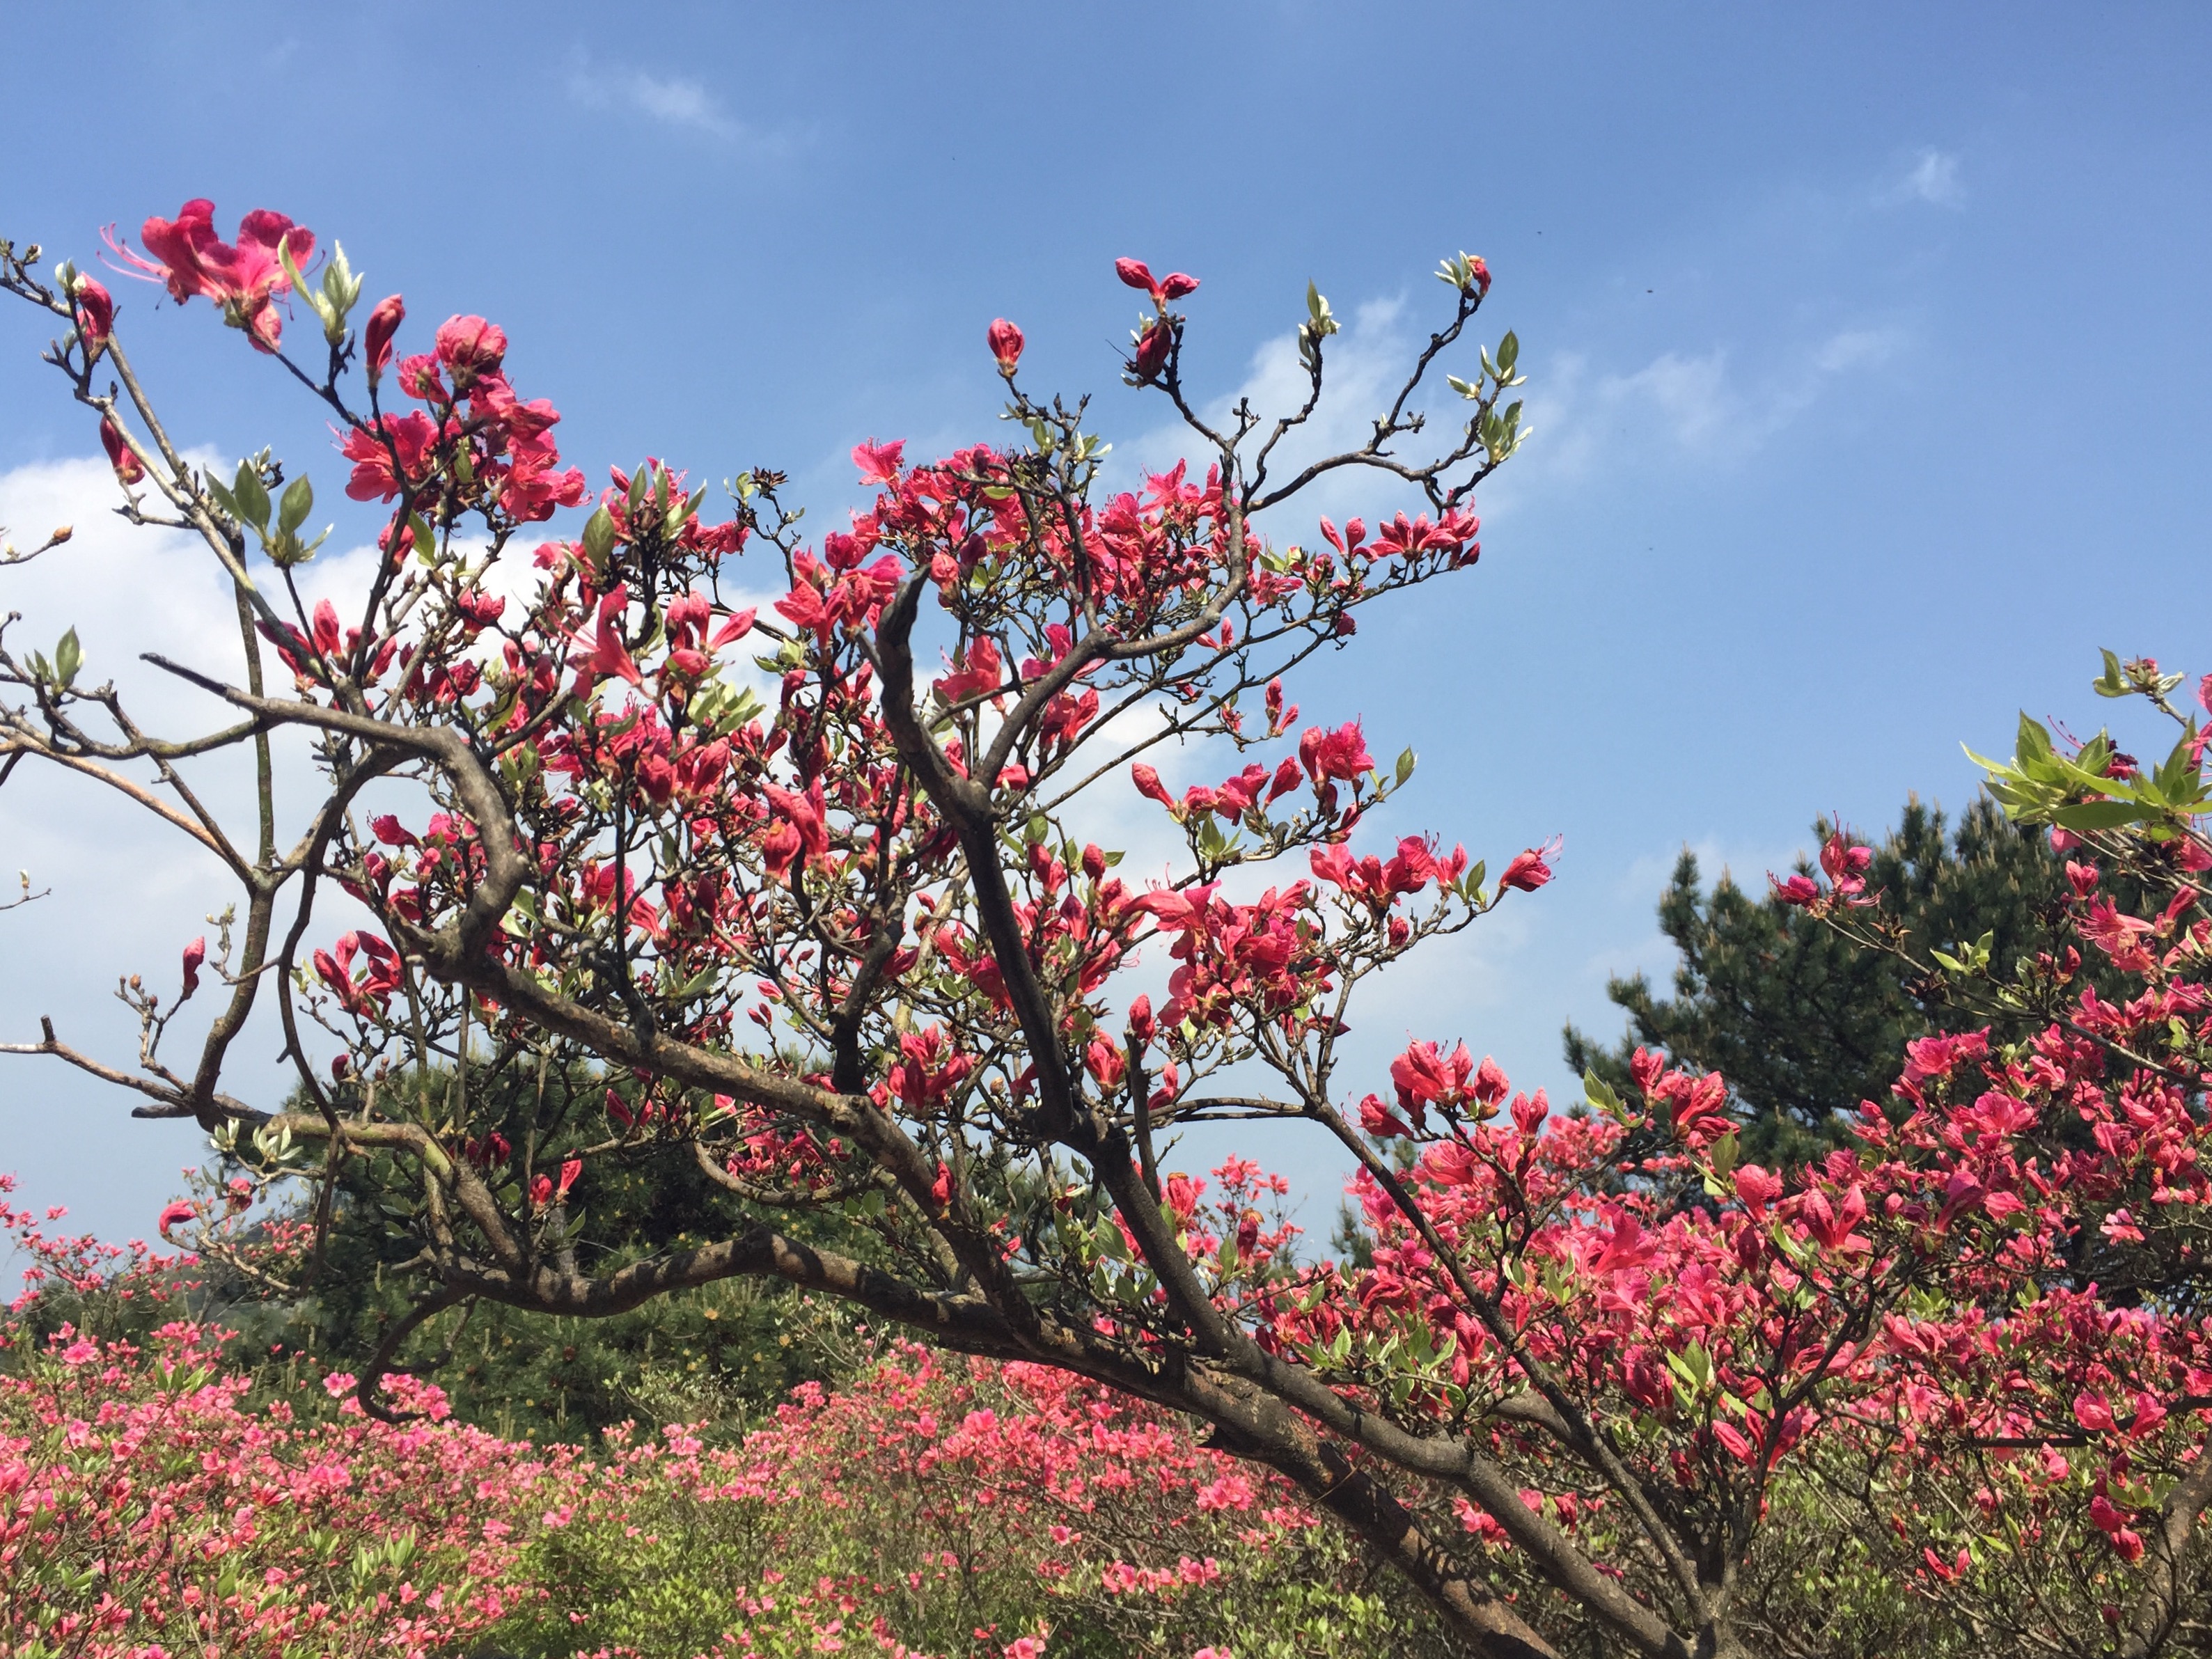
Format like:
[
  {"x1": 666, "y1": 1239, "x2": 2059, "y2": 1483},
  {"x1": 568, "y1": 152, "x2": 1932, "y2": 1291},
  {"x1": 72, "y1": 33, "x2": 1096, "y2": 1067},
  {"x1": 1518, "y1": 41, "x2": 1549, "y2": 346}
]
[{"x1": 0, "y1": 1325, "x2": 561, "y2": 1659}]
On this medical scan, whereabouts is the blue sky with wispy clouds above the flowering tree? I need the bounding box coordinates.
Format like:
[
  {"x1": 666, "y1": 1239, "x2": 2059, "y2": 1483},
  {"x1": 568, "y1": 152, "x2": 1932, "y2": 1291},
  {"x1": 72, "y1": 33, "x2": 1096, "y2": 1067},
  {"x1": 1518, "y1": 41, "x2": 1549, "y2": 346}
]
[{"x1": 0, "y1": 4, "x2": 2212, "y2": 1234}]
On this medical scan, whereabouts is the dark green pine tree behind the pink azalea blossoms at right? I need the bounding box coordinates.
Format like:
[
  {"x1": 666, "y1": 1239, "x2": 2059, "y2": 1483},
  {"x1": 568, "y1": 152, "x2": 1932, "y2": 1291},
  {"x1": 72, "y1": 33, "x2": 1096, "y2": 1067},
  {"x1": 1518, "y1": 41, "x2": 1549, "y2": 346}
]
[{"x1": 1566, "y1": 796, "x2": 2066, "y2": 1165}]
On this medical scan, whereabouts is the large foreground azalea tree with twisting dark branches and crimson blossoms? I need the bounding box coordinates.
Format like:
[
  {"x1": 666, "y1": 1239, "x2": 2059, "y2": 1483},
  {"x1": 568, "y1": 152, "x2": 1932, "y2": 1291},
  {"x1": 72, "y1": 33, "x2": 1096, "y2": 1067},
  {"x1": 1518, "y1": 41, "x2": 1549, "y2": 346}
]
[{"x1": 0, "y1": 201, "x2": 2212, "y2": 1655}]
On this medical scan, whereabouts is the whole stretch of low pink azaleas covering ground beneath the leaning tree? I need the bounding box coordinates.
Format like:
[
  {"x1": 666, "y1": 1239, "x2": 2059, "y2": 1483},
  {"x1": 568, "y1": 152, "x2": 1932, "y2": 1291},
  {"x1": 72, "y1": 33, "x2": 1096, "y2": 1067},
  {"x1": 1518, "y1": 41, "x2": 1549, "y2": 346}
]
[{"x1": 0, "y1": 1188, "x2": 1449, "y2": 1659}]
